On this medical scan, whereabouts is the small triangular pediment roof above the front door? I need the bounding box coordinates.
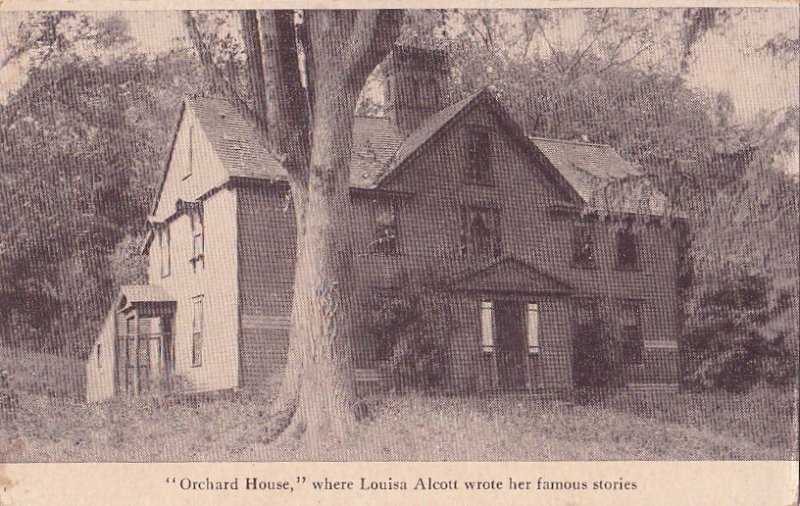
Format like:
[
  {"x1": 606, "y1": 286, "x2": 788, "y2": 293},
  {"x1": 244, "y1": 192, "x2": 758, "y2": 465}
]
[{"x1": 454, "y1": 255, "x2": 572, "y2": 295}]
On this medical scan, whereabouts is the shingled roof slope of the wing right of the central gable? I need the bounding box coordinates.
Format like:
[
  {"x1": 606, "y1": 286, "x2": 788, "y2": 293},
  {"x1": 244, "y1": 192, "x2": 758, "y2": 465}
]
[{"x1": 531, "y1": 137, "x2": 676, "y2": 216}]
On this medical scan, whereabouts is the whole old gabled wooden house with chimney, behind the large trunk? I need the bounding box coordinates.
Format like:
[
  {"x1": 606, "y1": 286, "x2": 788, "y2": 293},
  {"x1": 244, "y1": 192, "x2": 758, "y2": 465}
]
[{"x1": 86, "y1": 47, "x2": 680, "y2": 401}]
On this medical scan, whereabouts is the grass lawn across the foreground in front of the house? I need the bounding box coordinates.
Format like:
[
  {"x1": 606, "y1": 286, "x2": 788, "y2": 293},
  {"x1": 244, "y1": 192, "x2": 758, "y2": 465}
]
[{"x1": 0, "y1": 390, "x2": 797, "y2": 462}]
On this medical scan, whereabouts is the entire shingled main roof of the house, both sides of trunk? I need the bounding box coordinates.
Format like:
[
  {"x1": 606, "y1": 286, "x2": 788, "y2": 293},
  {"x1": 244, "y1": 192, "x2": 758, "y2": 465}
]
[{"x1": 154, "y1": 88, "x2": 668, "y2": 225}]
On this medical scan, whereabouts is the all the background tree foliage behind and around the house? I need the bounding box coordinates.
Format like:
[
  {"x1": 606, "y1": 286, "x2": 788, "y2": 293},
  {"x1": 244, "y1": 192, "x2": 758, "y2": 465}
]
[{"x1": 0, "y1": 9, "x2": 800, "y2": 388}]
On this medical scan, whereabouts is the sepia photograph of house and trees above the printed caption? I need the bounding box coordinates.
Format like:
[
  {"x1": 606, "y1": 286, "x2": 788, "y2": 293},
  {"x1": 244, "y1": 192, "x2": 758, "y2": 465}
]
[{"x1": 0, "y1": 3, "x2": 800, "y2": 470}]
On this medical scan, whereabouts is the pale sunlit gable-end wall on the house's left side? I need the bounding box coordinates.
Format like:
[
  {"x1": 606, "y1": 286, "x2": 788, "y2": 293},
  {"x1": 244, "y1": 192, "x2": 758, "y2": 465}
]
[{"x1": 148, "y1": 110, "x2": 239, "y2": 391}]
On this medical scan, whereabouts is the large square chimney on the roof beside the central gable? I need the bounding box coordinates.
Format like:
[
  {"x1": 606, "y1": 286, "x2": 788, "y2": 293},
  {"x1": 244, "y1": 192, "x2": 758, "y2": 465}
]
[{"x1": 383, "y1": 45, "x2": 450, "y2": 135}]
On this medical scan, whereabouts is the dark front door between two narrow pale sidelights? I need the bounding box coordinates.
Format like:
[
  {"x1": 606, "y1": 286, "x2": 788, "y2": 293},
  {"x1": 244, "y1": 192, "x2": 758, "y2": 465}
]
[{"x1": 495, "y1": 301, "x2": 527, "y2": 390}]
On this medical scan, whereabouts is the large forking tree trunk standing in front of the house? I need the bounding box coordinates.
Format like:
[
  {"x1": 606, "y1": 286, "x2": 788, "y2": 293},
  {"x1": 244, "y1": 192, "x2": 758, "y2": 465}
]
[{"x1": 186, "y1": 10, "x2": 402, "y2": 441}]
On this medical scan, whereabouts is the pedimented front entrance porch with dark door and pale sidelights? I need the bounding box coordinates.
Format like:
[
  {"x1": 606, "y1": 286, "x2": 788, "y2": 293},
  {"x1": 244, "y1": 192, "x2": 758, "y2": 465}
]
[{"x1": 453, "y1": 256, "x2": 573, "y2": 392}]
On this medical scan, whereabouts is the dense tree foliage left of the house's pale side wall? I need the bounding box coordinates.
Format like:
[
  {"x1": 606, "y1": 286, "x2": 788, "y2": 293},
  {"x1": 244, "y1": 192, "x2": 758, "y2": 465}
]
[{"x1": 0, "y1": 13, "x2": 199, "y2": 351}]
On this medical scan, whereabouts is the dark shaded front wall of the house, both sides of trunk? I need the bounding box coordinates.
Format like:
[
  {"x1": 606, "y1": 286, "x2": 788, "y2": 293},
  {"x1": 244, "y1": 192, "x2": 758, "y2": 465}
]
[{"x1": 227, "y1": 99, "x2": 679, "y2": 390}]
